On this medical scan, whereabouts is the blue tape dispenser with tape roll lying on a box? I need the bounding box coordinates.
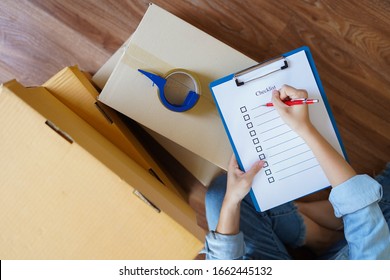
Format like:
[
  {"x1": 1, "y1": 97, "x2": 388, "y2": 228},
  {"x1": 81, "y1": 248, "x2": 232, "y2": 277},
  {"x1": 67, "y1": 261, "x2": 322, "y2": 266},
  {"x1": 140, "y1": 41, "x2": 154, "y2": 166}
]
[{"x1": 138, "y1": 69, "x2": 200, "y2": 112}]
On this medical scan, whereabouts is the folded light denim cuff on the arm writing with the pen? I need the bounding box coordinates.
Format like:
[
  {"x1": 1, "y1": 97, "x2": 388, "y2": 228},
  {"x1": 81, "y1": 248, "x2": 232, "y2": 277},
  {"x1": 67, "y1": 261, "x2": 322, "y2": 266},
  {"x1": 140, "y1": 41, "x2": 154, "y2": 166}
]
[{"x1": 329, "y1": 175, "x2": 382, "y2": 218}]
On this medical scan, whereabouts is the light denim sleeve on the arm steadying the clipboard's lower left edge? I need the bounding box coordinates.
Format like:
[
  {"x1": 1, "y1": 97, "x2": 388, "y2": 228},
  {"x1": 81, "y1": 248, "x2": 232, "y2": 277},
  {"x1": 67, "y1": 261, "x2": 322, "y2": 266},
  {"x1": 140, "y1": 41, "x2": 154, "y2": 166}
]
[{"x1": 202, "y1": 231, "x2": 245, "y2": 260}]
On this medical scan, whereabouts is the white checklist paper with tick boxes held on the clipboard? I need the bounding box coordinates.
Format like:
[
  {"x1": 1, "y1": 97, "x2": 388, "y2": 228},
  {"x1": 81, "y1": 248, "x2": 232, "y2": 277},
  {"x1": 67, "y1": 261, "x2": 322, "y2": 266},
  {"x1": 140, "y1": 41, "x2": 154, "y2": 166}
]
[{"x1": 210, "y1": 50, "x2": 343, "y2": 211}]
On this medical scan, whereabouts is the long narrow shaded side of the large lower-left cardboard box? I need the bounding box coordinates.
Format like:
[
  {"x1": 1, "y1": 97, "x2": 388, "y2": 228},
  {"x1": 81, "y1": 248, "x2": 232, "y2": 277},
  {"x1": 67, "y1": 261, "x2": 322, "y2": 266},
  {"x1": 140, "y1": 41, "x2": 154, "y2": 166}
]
[{"x1": 2, "y1": 81, "x2": 204, "y2": 240}]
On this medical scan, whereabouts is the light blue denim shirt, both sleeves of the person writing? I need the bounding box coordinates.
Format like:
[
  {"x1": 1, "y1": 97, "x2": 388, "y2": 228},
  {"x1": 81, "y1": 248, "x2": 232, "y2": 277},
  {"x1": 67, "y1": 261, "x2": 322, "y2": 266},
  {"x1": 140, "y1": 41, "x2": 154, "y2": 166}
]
[{"x1": 204, "y1": 175, "x2": 390, "y2": 259}]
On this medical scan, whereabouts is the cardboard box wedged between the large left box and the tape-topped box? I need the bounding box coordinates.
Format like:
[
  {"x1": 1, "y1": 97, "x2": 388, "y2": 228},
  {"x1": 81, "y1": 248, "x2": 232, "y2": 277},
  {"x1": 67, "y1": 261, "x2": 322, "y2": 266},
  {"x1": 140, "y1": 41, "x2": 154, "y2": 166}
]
[{"x1": 43, "y1": 66, "x2": 183, "y2": 196}]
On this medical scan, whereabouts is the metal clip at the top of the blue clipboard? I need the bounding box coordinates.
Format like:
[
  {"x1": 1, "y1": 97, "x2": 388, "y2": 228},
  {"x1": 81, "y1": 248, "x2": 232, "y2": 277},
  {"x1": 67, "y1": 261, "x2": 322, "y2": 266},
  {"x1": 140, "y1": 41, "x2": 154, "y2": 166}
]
[{"x1": 234, "y1": 56, "x2": 288, "y2": 87}]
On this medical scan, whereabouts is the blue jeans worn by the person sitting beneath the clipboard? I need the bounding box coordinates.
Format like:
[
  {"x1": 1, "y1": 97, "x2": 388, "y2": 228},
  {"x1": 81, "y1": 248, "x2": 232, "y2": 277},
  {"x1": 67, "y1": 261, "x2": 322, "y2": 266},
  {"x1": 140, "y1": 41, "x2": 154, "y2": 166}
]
[{"x1": 205, "y1": 163, "x2": 390, "y2": 259}]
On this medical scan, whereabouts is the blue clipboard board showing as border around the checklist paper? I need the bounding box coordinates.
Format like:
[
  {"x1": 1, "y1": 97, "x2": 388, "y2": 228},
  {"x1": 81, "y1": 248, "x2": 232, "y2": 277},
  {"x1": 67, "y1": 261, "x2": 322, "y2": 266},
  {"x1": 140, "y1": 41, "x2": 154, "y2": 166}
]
[{"x1": 209, "y1": 46, "x2": 348, "y2": 212}]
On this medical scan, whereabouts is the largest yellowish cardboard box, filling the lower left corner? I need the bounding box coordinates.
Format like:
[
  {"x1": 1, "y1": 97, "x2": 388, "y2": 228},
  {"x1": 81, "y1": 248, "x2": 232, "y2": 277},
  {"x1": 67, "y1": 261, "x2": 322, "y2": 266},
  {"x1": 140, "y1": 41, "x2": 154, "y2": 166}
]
[{"x1": 0, "y1": 81, "x2": 204, "y2": 259}]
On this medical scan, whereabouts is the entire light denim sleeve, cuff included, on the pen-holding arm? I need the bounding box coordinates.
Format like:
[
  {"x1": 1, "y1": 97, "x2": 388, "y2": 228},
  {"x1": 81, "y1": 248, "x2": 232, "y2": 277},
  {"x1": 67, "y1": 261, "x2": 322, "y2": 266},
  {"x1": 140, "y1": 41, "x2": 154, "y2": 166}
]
[{"x1": 329, "y1": 175, "x2": 390, "y2": 259}]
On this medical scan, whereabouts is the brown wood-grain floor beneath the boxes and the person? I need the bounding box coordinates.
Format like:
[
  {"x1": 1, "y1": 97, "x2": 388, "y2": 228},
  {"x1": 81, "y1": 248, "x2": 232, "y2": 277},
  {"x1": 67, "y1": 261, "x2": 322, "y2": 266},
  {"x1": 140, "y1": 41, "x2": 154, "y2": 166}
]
[{"x1": 0, "y1": 0, "x2": 390, "y2": 234}]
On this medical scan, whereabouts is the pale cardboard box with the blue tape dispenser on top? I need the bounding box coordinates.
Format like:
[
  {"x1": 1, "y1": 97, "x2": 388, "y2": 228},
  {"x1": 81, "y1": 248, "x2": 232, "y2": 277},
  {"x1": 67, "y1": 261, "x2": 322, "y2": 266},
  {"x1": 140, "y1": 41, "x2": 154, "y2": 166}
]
[{"x1": 99, "y1": 4, "x2": 256, "y2": 170}]
